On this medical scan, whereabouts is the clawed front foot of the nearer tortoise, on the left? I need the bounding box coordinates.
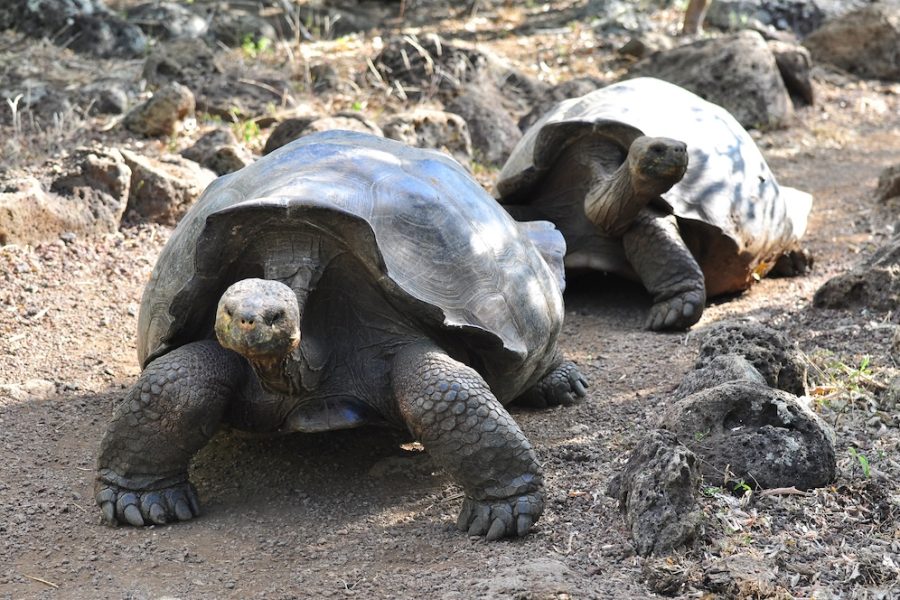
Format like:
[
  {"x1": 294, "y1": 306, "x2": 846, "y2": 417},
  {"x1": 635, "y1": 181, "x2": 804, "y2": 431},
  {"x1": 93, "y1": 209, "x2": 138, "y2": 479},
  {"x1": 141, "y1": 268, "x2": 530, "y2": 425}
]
[{"x1": 94, "y1": 481, "x2": 200, "y2": 527}]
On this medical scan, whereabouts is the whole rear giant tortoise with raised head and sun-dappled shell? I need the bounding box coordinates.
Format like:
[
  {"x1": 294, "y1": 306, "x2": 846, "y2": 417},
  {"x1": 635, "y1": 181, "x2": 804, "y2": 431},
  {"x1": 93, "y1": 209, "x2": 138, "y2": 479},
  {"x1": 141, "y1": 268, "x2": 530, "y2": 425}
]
[{"x1": 497, "y1": 77, "x2": 812, "y2": 329}]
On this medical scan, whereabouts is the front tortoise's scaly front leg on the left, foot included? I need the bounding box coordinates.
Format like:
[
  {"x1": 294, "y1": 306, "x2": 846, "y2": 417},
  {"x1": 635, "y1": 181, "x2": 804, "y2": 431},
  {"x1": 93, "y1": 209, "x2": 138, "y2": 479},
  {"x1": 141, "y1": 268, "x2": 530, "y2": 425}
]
[{"x1": 94, "y1": 341, "x2": 247, "y2": 527}]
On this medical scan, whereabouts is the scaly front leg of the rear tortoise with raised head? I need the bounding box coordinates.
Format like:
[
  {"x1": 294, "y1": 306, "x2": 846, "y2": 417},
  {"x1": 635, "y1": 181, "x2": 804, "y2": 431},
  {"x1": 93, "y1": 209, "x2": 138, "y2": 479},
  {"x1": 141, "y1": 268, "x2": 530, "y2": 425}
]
[{"x1": 622, "y1": 207, "x2": 706, "y2": 330}]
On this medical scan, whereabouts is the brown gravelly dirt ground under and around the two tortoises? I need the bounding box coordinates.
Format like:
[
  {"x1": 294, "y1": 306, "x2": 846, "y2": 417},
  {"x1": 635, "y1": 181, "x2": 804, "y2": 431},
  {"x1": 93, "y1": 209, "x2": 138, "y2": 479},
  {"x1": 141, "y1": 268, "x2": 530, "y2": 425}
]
[{"x1": 0, "y1": 2, "x2": 900, "y2": 599}]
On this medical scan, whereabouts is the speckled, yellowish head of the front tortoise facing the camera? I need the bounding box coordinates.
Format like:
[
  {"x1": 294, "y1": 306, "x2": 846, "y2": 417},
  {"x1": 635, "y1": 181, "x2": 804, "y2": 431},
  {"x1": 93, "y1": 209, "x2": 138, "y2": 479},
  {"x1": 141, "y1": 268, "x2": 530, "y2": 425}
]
[{"x1": 216, "y1": 279, "x2": 300, "y2": 364}]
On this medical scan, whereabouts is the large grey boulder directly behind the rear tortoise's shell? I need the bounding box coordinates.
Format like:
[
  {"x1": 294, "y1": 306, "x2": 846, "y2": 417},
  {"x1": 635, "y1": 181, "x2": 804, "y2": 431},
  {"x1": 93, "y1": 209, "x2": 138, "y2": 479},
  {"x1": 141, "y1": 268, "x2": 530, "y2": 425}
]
[{"x1": 628, "y1": 31, "x2": 793, "y2": 128}]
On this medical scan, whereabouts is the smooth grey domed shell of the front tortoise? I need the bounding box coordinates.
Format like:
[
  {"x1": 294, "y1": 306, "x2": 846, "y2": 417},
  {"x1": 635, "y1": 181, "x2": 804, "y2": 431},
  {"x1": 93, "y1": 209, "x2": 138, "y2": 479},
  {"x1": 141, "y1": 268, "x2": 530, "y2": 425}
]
[{"x1": 138, "y1": 131, "x2": 565, "y2": 396}]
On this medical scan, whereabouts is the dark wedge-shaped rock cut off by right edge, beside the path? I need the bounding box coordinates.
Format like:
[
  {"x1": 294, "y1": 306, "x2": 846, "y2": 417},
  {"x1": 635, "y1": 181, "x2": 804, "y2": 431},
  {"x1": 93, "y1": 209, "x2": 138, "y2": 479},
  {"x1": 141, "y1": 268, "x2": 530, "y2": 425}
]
[{"x1": 813, "y1": 234, "x2": 900, "y2": 312}]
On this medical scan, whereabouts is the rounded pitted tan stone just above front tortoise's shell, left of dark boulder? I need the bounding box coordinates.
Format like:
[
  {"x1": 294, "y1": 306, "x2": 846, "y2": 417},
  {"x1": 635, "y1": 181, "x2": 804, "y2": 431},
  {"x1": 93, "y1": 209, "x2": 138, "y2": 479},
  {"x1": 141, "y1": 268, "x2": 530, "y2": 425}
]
[{"x1": 381, "y1": 108, "x2": 472, "y2": 166}]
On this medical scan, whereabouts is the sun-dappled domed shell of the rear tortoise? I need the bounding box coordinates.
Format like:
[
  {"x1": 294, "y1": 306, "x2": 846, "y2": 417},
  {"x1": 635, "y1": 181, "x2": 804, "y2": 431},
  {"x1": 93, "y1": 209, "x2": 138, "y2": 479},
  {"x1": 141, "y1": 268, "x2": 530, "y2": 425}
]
[{"x1": 497, "y1": 77, "x2": 812, "y2": 284}]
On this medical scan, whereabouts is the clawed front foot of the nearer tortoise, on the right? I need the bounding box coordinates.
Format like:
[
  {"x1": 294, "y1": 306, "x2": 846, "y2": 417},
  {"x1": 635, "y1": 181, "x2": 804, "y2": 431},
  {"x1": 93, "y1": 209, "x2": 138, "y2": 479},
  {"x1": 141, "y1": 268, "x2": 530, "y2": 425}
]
[{"x1": 456, "y1": 491, "x2": 544, "y2": 542}]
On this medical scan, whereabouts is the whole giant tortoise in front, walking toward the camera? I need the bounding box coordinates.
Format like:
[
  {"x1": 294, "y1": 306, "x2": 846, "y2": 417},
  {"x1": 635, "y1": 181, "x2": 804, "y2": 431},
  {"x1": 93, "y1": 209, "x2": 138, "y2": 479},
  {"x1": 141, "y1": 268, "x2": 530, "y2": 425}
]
[{"x1": 95, "y1": 131, "x2": 587, "y2": 539}]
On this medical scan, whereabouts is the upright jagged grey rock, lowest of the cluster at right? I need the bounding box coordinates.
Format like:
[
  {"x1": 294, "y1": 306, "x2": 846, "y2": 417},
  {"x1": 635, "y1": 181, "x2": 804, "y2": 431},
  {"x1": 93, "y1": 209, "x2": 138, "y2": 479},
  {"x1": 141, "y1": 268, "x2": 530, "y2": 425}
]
[{"x1": 607, "y1": 429, "x2": 701, "y2": 556}]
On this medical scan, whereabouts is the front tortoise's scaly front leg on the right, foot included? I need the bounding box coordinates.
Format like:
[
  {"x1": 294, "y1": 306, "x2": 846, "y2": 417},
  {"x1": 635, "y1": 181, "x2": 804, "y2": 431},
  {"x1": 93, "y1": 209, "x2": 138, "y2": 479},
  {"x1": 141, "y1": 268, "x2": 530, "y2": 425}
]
[{"x1": 392, "y1": 344, "x2": 544, "y2": 540}]
